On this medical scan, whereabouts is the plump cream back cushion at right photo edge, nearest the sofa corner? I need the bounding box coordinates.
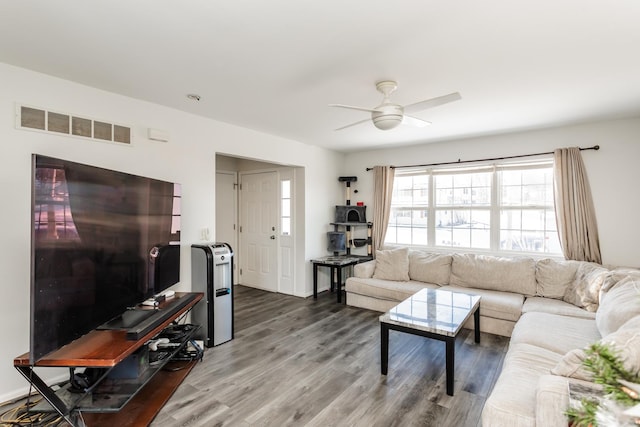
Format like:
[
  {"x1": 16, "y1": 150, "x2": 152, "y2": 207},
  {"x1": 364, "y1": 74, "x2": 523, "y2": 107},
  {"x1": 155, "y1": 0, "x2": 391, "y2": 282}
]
[{"x1": 596, "y1": 276, "x2": 640, "y2": 336}]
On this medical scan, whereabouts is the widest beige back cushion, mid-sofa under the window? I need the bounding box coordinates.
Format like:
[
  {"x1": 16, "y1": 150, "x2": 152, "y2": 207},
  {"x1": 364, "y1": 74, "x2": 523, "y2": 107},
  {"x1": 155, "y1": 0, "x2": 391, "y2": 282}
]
[{"x1": 449, "y1": 254, "x2": 536, "y2": 296}]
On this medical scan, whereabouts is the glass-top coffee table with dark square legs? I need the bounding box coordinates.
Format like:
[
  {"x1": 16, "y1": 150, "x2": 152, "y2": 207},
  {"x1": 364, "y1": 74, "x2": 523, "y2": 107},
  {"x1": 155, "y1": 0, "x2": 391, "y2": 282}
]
[{"x1": 380, "y1": 288, "x2": 480, "y2": 396}]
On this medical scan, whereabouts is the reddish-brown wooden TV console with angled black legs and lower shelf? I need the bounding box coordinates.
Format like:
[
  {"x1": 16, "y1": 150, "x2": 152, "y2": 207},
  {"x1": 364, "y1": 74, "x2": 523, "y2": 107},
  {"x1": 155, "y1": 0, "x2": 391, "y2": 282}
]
[{"x1": 13, "y1": 293, "x2": 203, "y2": 427}]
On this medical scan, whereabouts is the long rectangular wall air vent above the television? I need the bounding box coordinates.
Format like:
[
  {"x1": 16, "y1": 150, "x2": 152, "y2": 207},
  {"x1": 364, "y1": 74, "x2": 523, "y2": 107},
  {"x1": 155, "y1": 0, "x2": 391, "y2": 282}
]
[{"x1": 16, "y1": 105, "x2": 131, "y2": 145}]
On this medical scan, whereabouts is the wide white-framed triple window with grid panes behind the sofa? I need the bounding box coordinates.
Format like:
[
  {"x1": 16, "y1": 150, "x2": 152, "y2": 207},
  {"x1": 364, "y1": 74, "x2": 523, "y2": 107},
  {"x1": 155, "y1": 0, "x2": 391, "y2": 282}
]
[{"x1": 385, "y1": 161, "x2": 561, "y2": 254}]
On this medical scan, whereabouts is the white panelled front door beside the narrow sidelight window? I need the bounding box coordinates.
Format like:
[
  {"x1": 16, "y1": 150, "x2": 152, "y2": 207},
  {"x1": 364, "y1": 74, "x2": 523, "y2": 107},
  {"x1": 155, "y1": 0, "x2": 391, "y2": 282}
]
[{"x1": 240, "y1": 172, "x2": 278, "y2": 292}]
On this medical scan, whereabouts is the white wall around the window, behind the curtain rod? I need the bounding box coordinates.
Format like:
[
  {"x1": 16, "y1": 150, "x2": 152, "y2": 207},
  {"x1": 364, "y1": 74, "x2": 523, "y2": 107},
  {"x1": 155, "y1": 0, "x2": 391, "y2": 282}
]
[{"x1": 343, "y1": 118, "x2": 640, "y2": 267}]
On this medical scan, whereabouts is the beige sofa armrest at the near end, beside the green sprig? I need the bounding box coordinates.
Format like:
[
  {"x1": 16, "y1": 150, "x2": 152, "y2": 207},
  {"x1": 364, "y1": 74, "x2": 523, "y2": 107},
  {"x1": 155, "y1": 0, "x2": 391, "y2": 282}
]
[{"x1": 536, "y1": 374, "x2": 600, "y2": 427}]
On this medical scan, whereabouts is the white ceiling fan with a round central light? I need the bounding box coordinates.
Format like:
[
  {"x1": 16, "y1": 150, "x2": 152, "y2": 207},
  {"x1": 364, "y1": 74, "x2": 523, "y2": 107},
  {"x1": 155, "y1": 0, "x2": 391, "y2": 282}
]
[{"x1": 329, "y1": 80, "x2": 462, "y2": 130}]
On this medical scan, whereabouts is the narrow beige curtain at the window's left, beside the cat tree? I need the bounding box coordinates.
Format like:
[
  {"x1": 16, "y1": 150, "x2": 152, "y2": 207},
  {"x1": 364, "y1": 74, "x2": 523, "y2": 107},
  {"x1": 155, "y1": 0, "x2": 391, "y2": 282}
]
[{"x1": 372, "y1": 166, "x2": 394, "y2": 255}]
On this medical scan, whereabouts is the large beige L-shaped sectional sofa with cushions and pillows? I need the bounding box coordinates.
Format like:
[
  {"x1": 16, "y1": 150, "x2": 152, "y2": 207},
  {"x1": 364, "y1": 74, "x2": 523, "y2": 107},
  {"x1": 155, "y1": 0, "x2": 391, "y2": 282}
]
[{"x1": 345, "y1": 248, "x2": 640, "y2": 427}]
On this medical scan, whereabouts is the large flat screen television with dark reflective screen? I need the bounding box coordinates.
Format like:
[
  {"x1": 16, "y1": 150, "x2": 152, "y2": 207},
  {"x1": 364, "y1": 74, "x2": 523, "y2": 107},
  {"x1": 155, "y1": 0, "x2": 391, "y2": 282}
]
[{"x1": 30, "y1": 154, "x2": 181, "y2": 364}]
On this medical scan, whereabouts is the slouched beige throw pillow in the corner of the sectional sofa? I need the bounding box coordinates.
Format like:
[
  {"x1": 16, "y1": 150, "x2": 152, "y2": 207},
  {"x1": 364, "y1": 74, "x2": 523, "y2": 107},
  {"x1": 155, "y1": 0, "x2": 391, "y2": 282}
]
[{"x1": 562, "y1": 262, "x2": 609, "y2": 311}]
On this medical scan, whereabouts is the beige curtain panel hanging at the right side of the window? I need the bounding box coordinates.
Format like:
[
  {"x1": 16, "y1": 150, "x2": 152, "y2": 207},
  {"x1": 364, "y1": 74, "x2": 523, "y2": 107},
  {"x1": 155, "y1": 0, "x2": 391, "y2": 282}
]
[{"x1": 553, "y1": 147, "x2": 602, "y2": 264}]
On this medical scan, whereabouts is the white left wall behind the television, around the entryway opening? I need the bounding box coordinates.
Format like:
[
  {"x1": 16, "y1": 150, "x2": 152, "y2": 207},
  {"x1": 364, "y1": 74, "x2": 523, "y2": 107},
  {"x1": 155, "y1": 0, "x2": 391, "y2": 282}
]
[{"x1": 0, "y1": 64, "x2": 343, "y2": 402}]
